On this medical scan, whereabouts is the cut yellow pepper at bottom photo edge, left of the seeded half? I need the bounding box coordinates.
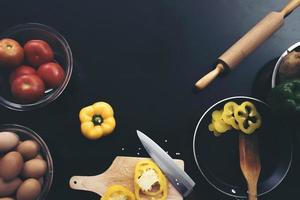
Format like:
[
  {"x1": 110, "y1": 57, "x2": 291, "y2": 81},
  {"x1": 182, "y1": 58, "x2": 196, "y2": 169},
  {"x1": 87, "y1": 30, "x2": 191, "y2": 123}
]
[{"x1": 100, "y1": 185, "x2": 135, "y2": 200}]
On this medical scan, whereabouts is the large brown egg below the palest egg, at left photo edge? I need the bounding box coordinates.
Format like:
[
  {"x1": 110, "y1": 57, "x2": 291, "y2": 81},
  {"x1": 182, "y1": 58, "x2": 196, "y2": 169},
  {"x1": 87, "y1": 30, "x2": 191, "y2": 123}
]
[{"x1": 0, "y1": 151, "x2": 24, "y2": 181}]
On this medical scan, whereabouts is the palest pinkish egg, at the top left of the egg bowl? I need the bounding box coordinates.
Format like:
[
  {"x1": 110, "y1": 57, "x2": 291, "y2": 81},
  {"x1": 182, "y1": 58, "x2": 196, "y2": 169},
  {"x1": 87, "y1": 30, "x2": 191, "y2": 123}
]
[{"x1": 0, "y1": 132, "x2": 19, "y2": 153}]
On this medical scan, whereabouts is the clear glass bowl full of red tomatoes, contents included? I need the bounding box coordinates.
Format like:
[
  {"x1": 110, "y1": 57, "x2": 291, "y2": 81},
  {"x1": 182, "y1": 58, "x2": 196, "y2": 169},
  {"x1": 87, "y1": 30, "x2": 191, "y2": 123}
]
[{"x1": 0, "y1": 23, "x2": 73, "y2": 111}]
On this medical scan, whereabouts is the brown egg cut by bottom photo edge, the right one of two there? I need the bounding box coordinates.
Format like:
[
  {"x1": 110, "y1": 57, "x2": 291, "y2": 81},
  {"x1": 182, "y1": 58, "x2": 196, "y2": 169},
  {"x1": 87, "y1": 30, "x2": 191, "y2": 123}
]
[{"x1": 17, "y1": 178, "x2": 41, "y2": 200}]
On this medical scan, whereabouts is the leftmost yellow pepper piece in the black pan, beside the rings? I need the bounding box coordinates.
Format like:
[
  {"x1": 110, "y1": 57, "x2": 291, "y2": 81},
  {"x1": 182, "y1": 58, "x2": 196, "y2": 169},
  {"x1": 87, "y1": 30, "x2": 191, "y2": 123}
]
[{"x1": 208, "y1": 110, "x2": 231, "y2": 135}]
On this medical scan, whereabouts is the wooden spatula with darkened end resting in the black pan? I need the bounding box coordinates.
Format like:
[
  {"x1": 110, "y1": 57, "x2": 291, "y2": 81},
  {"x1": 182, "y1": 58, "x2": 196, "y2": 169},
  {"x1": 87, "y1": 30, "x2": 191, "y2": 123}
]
[{"x1": 239, "y1": 133, "x2": 261, "y2": 200}]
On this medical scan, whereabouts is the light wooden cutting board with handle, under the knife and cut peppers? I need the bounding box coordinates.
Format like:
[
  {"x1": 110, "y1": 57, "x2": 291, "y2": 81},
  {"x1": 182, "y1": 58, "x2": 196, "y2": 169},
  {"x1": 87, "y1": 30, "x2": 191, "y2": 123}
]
[{"x1": 69, "y1": 156, "x2": 184, "y2": 200}]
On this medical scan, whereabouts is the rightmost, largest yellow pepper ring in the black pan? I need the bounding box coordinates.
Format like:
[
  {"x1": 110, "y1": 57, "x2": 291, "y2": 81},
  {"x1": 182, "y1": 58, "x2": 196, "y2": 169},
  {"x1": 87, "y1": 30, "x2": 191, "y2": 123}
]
[{"x1": 234, "y1": 101, "x2": 261, "y2": 134}]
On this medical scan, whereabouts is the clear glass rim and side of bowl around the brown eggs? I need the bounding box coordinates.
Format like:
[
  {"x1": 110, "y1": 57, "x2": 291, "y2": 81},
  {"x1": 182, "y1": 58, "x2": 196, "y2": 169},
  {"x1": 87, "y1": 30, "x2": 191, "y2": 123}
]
[{"x1": 0, "y1": 124, "x2": 53, "y2": 200}]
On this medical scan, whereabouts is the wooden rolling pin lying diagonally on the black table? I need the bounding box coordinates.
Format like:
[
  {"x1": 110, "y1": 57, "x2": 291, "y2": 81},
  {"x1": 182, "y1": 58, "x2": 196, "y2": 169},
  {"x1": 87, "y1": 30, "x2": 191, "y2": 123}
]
[{"x1": 195, "y1": 0, "x2": 300, "y2": 89}]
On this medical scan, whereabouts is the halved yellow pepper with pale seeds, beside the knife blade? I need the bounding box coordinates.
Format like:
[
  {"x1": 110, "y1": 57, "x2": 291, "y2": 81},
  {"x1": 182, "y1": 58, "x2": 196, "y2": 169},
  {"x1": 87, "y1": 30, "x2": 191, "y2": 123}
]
[{"x1": 134, "y1": 159, "x2": 168, "y2": 200}]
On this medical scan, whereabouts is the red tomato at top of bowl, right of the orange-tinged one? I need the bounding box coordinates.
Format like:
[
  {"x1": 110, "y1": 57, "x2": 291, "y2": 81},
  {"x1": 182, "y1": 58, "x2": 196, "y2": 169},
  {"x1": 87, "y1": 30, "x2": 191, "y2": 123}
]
[{"x1": 24, "y1": 40, "x2": 54, "y2": 67}]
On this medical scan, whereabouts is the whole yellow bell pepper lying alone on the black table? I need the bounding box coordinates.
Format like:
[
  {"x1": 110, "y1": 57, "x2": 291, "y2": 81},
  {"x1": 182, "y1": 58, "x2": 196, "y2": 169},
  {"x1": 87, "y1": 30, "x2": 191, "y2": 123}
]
[{"x1": 79, "y1": 102, "x2": 116, "y2": 140}]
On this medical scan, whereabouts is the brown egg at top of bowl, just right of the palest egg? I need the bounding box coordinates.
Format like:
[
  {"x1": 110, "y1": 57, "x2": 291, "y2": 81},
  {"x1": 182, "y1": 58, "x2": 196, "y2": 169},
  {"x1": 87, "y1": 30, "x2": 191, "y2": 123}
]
[{"x1": 17, "y1": 140, "x2": 40, "y2": 160}]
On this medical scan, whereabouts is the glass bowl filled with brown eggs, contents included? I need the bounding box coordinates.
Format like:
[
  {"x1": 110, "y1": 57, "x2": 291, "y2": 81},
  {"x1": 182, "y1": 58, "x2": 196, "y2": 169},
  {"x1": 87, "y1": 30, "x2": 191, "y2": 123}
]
[{"x1": 0, "y1": 124, "x2": 53, "y2": 200}]
